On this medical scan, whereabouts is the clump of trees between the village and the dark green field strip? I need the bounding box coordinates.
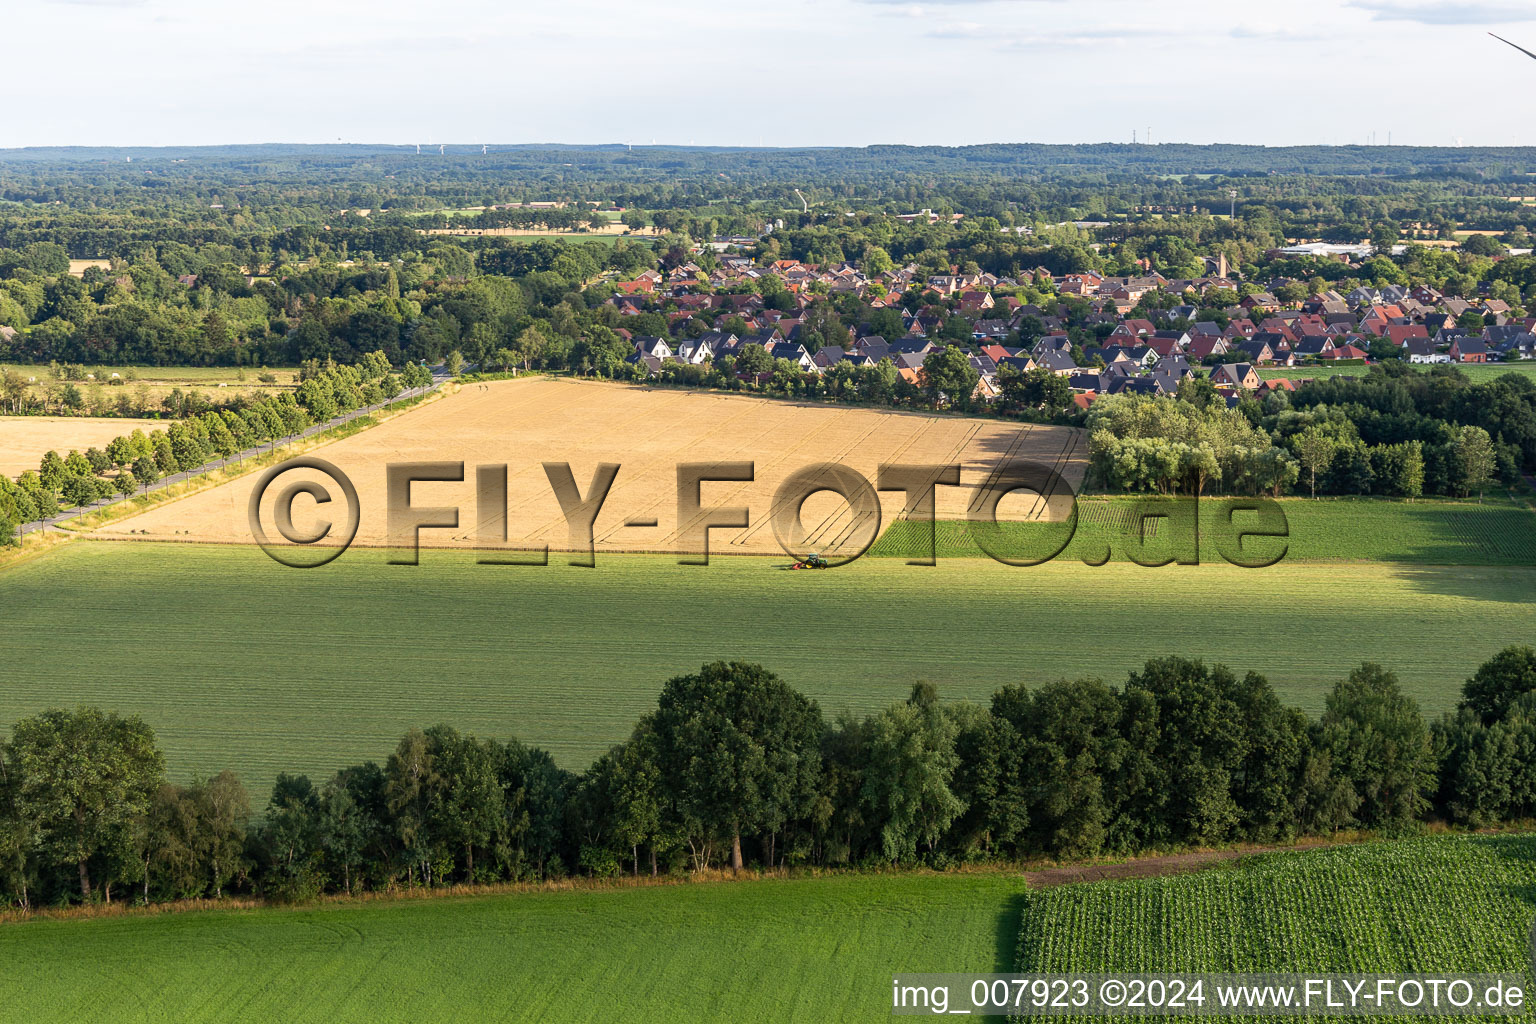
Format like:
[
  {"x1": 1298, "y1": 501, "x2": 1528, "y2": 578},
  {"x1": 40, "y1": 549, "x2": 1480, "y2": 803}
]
[{"x1": 1083, "y1": 364, "x2": 1536, "y2": 497}]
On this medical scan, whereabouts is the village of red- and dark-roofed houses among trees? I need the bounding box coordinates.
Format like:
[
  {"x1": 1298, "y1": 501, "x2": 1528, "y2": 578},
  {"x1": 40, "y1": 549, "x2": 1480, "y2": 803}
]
[{"x1": 610, "y1": 239, "x2": 1536, "y2": 408}]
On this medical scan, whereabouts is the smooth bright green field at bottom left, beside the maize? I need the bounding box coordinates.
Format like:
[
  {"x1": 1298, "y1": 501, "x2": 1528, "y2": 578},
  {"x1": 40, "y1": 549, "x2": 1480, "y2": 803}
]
[{"x1": 0, "y1": 874, "x2": 1025, "y2": 1024}]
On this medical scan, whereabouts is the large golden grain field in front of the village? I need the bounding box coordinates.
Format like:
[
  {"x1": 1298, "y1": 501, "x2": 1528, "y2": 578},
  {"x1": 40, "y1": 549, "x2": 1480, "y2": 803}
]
[{"x1": 100, "y1": 378, "x2": 1087, "y2": 554}]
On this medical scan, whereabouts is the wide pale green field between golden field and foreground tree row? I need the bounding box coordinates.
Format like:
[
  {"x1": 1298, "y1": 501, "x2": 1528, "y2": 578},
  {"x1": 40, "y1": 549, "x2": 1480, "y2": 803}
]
[{"x1": 0, "y1": 542, "x2": 1536, "y2": 801}]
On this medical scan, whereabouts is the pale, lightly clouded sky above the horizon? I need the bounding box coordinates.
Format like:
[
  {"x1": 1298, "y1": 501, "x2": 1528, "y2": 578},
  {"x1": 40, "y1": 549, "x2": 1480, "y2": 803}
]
[{"x1": 9, "y1": 0, "x2": 1536, "y2": 147}]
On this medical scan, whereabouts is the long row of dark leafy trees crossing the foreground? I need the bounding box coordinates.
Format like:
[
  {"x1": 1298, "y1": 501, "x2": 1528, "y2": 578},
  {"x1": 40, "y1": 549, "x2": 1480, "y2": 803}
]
[{"x1": 0, "y1": 648, "x2": 1536, "y2": 907}]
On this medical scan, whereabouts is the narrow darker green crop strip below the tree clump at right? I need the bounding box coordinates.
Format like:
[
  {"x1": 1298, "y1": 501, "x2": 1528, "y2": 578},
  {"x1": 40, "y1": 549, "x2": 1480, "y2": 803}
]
[{"x1": 869, "y1": 496, "x2": 1536, "y2": 567}]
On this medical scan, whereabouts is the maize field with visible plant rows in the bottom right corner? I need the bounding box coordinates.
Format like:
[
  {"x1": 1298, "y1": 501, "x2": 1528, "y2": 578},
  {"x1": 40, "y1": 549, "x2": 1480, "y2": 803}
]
[{"x1": 1017, "y1": 835, "x2": 1536, "y2": 1019}]
